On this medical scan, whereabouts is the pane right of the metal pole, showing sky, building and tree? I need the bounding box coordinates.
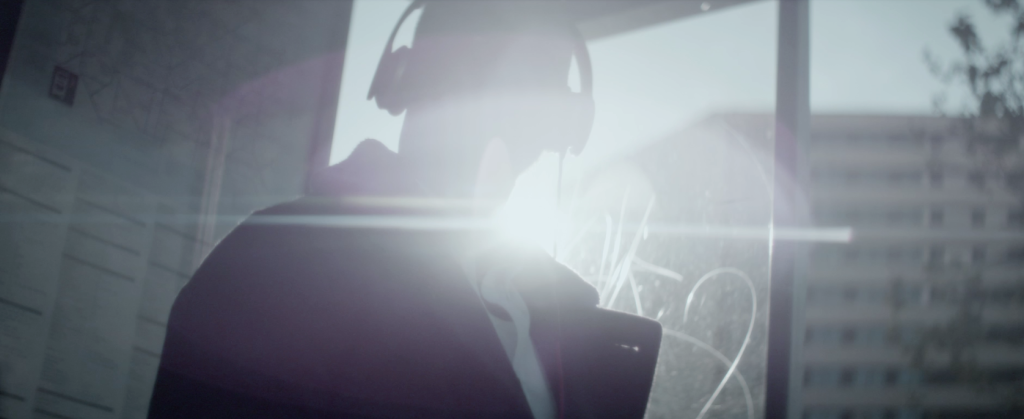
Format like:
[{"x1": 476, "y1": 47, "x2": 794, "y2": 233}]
[{"x1": 806, "y1": 0, "x2": 1024, "y2": 418}]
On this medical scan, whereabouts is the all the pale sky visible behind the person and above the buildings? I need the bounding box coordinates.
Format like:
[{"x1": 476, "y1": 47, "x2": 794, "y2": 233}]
[{"x1": 331, "y1": 0, "x2": 1008, "y2": 246}]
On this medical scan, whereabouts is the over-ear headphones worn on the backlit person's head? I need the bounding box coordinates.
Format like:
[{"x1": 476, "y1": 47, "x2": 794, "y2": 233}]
[{"x1": 367, "y1": 0, "x2": 594, "y2": 154}]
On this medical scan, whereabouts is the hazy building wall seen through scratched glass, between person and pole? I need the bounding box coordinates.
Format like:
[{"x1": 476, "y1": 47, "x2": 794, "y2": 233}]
[{"x1": 557, "y1": 121, "x2": 771, "y2": 419}]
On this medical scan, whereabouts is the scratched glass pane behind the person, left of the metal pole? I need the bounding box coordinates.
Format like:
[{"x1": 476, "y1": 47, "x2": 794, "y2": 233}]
[{"x1": 332, "y1": 0, "x2": 778, "y2": 418}]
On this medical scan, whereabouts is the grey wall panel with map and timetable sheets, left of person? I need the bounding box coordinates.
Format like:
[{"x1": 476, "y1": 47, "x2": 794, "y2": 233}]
[{"x1": 0, "y1": 0, "x2": 351, "y2": 418}]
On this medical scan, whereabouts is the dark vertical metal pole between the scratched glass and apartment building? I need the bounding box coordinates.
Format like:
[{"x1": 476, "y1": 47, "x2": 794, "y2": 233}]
[{"x1": 765, "y1": 0, "x2": 810, "y2": 419}]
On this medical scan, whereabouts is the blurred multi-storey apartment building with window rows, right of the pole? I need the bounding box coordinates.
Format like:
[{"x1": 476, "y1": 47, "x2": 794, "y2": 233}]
[{"x1": 795, "y1": 115, "x2": 1024, "y2": 419}]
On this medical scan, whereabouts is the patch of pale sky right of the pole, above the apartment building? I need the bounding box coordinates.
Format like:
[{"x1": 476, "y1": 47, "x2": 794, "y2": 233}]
[{"x1": 811, "y1": 0, "x2": 1009, "y2": 114}]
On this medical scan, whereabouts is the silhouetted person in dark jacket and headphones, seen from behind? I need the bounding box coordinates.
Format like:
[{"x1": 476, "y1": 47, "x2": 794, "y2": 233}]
[{"x1": 150, "y1": 1, "x2": 660, "y2": 419}]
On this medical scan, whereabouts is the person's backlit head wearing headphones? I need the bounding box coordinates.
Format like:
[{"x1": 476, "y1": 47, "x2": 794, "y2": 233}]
[{"x1": 370, "y1": 1, "x2": 593, "y2": 198}]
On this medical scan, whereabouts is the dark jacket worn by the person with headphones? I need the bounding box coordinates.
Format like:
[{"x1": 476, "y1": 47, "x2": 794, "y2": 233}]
[{"x1": 150, "y1": 141, "x2": 662, "y2": 419}]
